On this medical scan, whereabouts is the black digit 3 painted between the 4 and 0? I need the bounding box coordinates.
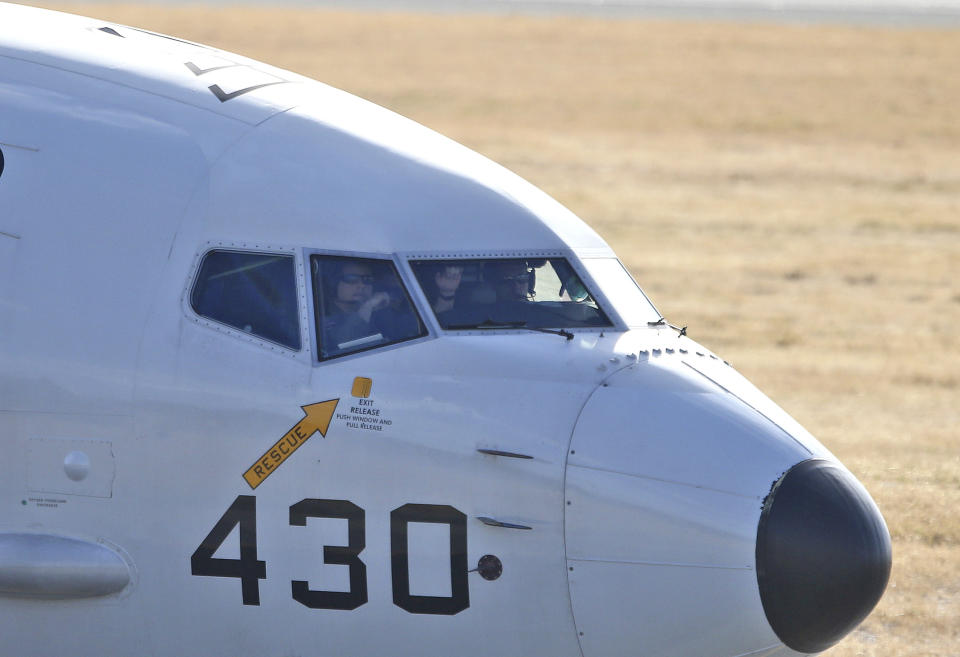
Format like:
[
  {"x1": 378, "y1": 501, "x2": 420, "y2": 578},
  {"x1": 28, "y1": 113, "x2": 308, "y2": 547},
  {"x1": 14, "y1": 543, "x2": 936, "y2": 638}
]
[{"x1": 290, "y1": 499, "x2": 367, "y2": 609}]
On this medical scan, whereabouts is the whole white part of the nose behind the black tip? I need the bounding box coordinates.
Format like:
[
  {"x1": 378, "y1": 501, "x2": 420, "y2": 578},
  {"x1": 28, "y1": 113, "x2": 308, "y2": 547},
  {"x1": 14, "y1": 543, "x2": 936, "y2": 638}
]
[{"x1": 565, "y1": 356, "x2": 810, "y2": 657}]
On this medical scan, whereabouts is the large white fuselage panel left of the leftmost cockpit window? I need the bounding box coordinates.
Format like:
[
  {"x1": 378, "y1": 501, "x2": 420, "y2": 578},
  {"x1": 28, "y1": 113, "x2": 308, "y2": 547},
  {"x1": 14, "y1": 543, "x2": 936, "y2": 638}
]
[{"x1": 0, "y1": 66, "x2": 225, "y2": 416}]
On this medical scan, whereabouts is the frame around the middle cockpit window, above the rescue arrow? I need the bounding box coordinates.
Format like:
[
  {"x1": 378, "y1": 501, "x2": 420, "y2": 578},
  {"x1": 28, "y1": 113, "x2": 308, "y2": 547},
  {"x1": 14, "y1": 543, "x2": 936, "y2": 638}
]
[{"x1": 303, "y1": 248, "x2": 439, "y2": 365}]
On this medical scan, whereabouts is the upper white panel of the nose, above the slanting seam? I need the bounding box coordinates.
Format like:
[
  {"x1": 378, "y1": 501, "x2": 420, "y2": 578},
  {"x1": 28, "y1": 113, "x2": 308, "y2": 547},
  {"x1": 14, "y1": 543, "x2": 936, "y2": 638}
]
[{"x1": 569, "y1": 358, "x2": 810, "y2": 498}]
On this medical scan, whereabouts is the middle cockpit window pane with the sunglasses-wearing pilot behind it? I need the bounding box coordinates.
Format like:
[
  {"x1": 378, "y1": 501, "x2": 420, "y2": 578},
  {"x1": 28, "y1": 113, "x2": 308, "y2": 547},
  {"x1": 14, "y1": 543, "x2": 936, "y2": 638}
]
[{"x1": 310, "y1": 255, "x2": 426, "y2": 359}]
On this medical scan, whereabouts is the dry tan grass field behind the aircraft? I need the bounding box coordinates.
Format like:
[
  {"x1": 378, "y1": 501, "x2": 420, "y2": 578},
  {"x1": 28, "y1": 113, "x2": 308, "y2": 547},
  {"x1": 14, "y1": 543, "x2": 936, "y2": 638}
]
[{"x1": 26, "y1": 4, "x2": 960, "y2": 657}]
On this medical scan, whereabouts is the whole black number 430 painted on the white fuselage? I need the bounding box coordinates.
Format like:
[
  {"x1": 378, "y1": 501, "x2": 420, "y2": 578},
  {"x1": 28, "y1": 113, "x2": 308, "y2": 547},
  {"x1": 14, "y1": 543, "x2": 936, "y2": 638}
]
[{"x1": 190, "y1": 495, "x2": 470, "y2": 615}]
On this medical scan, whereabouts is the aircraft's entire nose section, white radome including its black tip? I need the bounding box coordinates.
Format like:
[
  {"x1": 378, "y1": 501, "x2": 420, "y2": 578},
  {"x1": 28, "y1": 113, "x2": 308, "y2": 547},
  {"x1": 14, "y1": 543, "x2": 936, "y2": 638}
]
[{"x1": 564, "y1": 348, "x2": 890, "y2": 657}]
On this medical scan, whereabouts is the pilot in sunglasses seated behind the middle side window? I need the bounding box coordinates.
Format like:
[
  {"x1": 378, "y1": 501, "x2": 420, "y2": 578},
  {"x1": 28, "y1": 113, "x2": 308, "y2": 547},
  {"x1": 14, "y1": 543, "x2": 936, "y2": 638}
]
[{"x1": 323, "y1": 261, "x2": 390, "y2": 349}]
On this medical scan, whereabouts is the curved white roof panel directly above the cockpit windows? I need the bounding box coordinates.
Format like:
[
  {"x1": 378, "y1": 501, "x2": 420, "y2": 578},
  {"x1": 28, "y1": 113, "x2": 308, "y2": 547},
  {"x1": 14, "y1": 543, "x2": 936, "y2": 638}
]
[{"x1": 203, "y1": 105, "x2": 606, "y2": 253}]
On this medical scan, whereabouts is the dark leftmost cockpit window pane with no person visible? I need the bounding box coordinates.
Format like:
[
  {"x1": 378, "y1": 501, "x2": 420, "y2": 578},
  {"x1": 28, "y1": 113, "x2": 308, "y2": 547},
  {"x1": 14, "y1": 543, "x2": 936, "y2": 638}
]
[{"x1": 190, "y1": 251, "x2": 300, "y2": 349}]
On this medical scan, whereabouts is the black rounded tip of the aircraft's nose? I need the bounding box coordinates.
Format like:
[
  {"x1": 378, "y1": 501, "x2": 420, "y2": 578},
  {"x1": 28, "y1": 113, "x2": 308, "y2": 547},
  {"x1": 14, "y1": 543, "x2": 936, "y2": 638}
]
[{"x1": 756, "y1": 459, "x2": 891, "y2": 653}]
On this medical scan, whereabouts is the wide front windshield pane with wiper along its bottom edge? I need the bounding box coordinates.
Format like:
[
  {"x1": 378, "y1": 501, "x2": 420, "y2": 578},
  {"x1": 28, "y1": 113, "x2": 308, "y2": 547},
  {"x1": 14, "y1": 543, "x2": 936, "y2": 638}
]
[{"x1": 410, "y1": 258, "x2": 611, "y2": 330}]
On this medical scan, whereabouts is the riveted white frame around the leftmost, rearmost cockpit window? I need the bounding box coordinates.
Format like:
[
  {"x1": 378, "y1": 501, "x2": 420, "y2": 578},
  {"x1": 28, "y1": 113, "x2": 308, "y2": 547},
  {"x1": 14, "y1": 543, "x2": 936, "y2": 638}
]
[{"x1": 181, "y1": 241, "x2": 312, "y2": 360}]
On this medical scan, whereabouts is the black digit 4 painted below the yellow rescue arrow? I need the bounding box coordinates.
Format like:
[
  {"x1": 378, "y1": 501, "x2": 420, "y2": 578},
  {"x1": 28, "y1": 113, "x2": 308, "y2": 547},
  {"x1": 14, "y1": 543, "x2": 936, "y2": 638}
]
[{"x1": 190, "y1": 495, "x2": 267, "y2": 605}]
